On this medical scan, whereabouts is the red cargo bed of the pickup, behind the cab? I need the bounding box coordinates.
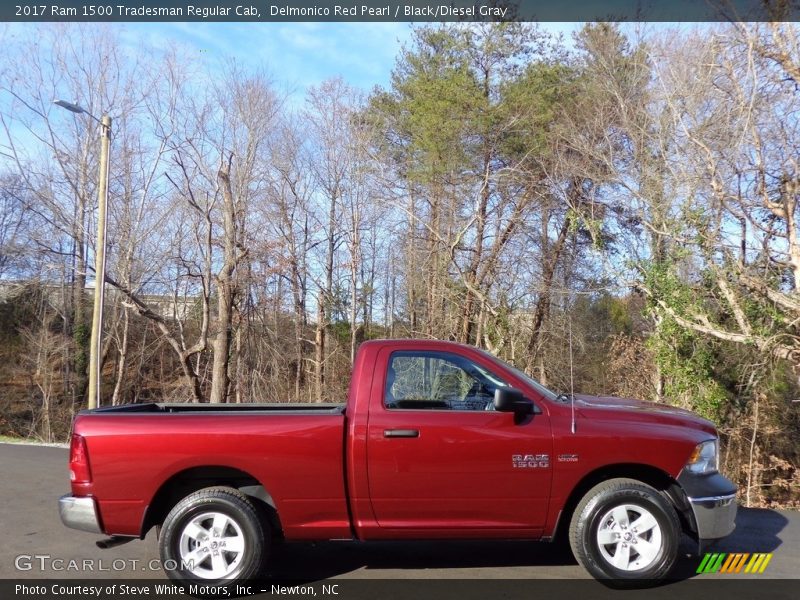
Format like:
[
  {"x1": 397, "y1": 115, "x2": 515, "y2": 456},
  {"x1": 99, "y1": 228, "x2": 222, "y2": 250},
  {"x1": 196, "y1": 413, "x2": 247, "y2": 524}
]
[{"x1": 72, "y1": 403, "x2": 350, "y2": 539}]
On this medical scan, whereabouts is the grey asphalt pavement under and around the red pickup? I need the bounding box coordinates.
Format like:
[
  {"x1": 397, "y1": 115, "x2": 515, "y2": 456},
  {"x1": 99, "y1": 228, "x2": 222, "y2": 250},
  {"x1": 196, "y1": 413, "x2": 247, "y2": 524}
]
[{"x1": 0, "y1": 443, "x2": 800, "y2": 581}]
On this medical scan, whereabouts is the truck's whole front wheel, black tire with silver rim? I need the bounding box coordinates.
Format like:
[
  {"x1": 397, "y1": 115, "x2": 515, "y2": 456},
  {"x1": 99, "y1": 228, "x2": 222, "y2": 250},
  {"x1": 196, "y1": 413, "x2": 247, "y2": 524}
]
[{"x1": 569, "y1": 479, "x2": 681, "y2": 587}]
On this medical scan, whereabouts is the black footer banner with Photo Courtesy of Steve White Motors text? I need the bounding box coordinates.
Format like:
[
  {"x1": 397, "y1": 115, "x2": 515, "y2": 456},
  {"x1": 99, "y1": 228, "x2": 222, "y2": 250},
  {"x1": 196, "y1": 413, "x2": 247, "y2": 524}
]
[{"x1": 0, "y1": 574, "x2": 800, "y2": 600}]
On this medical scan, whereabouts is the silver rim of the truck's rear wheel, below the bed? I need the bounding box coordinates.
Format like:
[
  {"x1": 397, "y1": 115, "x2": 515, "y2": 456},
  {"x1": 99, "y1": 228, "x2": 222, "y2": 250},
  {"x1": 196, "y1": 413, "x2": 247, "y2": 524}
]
[{"x1": 179, "y1": 512, "x2": 245, "y2": 579}]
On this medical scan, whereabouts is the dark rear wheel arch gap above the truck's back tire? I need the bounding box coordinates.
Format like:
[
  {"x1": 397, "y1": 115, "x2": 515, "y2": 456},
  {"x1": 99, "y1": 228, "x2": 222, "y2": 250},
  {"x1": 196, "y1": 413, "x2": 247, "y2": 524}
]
[{"x1": 141, "y1": 465, "x2": 283, "y2": 538}]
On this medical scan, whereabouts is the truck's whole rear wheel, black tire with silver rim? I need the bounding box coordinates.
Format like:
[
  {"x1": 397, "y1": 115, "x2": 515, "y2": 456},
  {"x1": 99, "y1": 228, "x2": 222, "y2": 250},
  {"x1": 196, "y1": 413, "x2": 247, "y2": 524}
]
[{"x1": 159, "y1": 487, "x2": 270, "y2": 585}]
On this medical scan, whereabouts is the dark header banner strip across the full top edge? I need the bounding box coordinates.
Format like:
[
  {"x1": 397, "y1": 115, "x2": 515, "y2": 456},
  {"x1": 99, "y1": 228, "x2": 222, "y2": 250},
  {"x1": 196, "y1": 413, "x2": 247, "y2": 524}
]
[{"x1": 0, "y1": 0, "x2": 800, "y2": 23}]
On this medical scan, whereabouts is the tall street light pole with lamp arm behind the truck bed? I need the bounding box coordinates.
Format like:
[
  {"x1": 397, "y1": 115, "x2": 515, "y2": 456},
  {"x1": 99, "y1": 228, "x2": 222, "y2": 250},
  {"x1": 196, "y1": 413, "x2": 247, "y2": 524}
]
[{"x1": 53, "y1": 100, "x2": 111, "y2": 408}]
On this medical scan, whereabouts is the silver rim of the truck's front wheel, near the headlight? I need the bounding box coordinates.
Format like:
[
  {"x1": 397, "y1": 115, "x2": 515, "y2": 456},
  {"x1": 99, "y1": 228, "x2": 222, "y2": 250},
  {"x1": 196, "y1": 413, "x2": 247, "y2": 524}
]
[{"x1": 597, "y1": 504, "x2": 663, "y2": 571}]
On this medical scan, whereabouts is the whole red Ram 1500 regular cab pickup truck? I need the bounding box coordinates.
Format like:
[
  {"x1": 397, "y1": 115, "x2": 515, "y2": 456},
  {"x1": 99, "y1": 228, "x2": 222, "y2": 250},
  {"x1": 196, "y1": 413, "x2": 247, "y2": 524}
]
[{"x1": 59, "y1": 340, "x2": 736, "y2": 583}]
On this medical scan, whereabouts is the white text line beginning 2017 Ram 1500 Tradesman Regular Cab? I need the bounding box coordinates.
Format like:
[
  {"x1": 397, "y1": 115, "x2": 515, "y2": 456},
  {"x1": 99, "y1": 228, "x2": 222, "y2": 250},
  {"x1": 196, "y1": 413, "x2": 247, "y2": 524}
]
[{"x1": 14, "y1": 3, "x2": 508, "y2": 20}]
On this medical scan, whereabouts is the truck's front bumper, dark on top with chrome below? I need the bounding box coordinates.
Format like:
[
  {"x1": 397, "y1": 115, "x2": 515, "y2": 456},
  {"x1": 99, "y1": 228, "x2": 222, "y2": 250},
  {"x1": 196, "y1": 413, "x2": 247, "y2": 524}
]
[{"x1": 678, "y1": 471, "x2": 737, "y2": 540}]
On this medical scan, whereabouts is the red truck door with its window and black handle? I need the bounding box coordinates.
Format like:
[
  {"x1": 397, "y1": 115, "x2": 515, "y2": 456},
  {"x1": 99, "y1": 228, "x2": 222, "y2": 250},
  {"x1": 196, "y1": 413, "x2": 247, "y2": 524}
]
[{"x1": 367, "y1": 349, "x2": 553, "y2": 535}]
